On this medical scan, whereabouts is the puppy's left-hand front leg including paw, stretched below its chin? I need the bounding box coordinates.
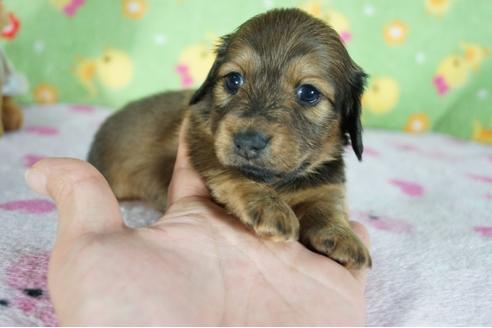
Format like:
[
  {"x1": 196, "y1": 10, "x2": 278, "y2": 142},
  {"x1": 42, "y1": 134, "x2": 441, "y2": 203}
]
[{"x1": 207, "y1": 172, "x2": 299, "y2": 241}]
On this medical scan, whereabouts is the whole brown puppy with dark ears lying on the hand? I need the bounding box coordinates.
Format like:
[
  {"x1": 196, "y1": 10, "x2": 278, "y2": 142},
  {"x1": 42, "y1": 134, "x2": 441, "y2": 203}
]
[{"x1": 89, "y1": 9, "x2": 371, "y2": 268}]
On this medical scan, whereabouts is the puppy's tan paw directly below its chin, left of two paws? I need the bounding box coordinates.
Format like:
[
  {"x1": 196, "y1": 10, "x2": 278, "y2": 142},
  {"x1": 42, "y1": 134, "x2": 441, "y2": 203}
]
[{"x1": 243, "y1": 197, "x2": 299, "y2": 241}]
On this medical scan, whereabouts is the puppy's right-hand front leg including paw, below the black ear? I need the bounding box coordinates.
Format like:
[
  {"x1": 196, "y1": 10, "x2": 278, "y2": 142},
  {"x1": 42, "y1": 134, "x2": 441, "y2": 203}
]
[{"x1": 295, "y1": 186, "x2": 371, "y2": 269}]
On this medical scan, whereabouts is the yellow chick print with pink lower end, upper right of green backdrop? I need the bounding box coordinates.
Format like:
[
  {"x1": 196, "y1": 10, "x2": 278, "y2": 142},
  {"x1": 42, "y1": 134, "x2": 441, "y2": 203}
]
[{"x1": 432, "y1": 42, "x2": 489, "y2": 96}]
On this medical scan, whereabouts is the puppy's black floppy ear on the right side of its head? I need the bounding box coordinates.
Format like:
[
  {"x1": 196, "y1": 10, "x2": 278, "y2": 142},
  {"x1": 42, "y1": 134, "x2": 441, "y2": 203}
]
[{"x1": 340, "y1": 63, "x2": 367, "y2": 161}]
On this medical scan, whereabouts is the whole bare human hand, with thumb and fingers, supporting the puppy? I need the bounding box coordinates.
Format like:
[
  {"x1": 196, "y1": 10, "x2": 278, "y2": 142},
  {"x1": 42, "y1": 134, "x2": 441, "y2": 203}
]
[{"x1": 26, "y1": 120, "x2": 368, "y2": 326}]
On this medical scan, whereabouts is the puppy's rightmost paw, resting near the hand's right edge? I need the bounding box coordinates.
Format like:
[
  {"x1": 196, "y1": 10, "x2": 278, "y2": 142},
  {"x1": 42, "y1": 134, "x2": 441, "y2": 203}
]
[{"x1": 303, "y1": 225, "x2": 372, "y2": 269}]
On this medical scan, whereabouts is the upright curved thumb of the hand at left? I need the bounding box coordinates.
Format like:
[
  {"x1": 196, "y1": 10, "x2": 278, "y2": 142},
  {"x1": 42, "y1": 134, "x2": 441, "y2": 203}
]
[{"x1": 26, "y1": 158, "x2": 124, "y2": 238}]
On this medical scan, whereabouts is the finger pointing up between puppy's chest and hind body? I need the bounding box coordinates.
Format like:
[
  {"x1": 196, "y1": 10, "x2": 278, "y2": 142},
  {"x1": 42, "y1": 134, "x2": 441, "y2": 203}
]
[{"x1": 167, "y1": 118, "x2": 209, "y2": 208}]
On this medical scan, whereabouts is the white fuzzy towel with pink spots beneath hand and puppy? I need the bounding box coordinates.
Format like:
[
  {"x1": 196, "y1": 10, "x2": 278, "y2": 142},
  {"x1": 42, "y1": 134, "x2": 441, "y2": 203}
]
[{"x1": 0, "y1": 105, "x2": 492, "y2": 326}]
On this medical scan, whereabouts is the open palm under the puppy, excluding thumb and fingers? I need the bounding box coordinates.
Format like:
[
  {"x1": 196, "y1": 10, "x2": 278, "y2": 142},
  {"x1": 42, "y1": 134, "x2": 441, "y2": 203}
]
[{"x1": 50, "y1": 200, "x2": 364, "y2": 325}]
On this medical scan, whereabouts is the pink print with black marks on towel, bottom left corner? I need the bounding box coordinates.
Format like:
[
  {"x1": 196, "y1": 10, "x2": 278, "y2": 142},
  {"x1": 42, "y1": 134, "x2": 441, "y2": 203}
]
[{"x1": 0, "y1": 252, "x2": 57, "y2": 326}]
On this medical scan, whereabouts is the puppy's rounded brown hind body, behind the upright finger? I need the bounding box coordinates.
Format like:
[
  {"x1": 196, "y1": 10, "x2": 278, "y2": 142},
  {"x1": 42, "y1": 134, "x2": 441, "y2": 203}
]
[{"x1": 88, "y1": 91, "x2": 190, "y2": 211}]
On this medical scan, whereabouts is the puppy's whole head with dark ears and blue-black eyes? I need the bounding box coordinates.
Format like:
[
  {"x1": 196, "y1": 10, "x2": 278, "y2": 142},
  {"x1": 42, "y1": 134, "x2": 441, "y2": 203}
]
[{"x1": 190, "y1": 9, "x2": 366, "y2": 183}]
